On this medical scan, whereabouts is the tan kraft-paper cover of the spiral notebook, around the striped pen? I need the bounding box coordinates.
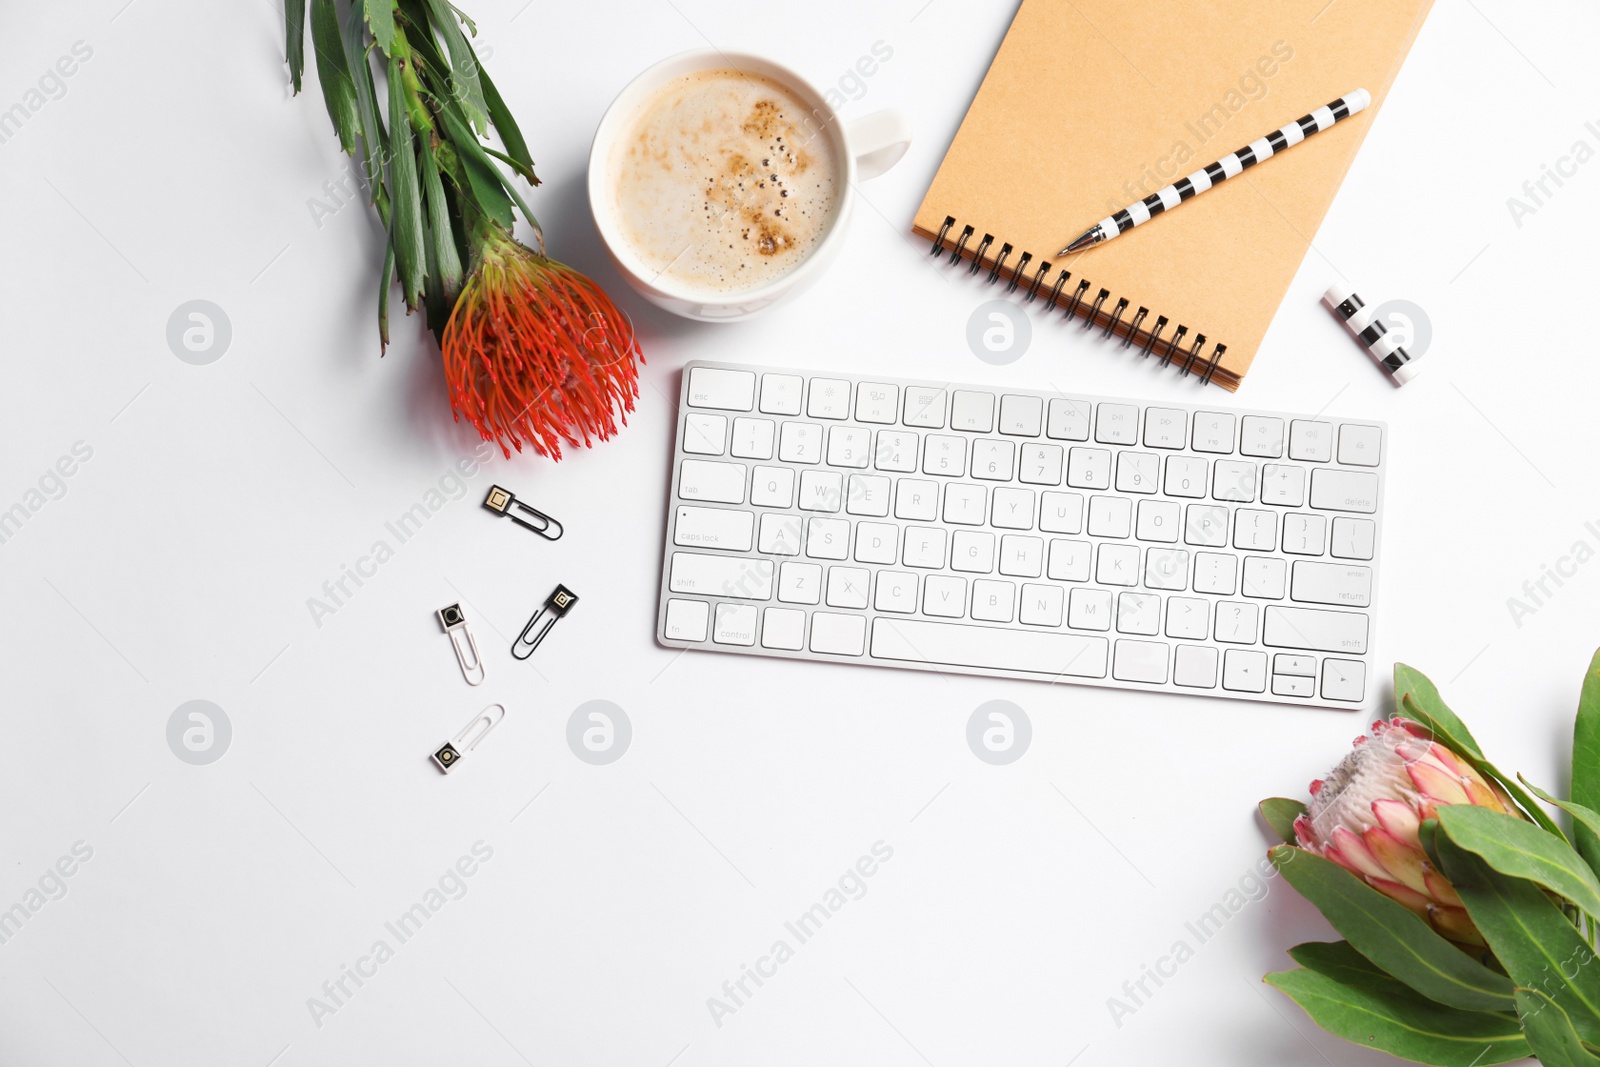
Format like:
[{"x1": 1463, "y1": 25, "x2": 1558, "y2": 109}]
[{"x1": 914, "y1": 0, "x2": 1432, "y2": 390}]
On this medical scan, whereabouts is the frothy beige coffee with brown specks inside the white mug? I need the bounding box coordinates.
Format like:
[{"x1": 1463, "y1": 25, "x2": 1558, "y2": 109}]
[{"x1": 611, "y1": 70, "x2": 843, "y2": 294}]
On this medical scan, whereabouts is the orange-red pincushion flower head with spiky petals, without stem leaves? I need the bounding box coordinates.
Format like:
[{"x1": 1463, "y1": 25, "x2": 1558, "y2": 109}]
[{"x1": 440, "y1": 226, "x2": 643, "y2": 459}]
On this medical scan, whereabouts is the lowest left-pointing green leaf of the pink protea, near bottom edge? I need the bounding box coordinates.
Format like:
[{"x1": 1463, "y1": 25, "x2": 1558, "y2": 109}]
[{"x1": 1264, "y1": 966, "x2": 1528, "y2": 1067}]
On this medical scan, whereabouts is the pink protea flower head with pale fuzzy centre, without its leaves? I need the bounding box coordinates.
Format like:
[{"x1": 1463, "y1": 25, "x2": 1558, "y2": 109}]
[{"x1": 1294, "y1": 718, "x2": 1522, "y2": 947}]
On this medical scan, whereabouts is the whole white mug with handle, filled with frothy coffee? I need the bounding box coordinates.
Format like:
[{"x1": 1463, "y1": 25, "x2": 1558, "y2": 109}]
[{"x1": 589, "y1": 50, "x2": 910, "y2": 320}]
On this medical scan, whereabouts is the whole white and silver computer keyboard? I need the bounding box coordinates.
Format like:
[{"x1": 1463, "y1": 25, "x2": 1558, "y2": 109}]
[{"x1": 656, "y1": 362, "x2": 1387, "y2": 707}]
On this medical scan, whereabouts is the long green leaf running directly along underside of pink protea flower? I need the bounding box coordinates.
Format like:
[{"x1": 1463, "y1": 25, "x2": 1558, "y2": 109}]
[{"x1": 1267, "y1": 845, "x2": 1514, "y2": 1011}]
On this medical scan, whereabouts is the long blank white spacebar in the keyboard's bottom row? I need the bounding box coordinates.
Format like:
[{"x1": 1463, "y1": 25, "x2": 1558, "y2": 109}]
[{"x1": 872, "y1": 617, "x2": 1110, "y2": 678}]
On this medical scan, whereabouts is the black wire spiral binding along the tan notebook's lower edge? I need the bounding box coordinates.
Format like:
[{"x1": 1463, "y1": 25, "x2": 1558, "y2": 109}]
[{"x1": 931, "y1": 214, "x2": 1227, "y2": 386}]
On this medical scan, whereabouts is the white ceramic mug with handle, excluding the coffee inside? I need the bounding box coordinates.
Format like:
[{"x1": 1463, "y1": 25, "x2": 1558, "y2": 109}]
[{"x1": 589, "y1": 48, "x2": 910, "y2": 322}]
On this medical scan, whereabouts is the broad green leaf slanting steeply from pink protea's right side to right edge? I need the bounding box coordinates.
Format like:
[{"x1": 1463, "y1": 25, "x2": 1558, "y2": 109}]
[{"x1": 1432, "y1": 830, "x2": 1600, "y2": 1041}]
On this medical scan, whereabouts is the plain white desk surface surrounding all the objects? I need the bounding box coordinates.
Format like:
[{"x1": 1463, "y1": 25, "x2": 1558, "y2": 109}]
[{"x1": 0, "y1": 0, "x2": 1600, "y2": 1067}]
